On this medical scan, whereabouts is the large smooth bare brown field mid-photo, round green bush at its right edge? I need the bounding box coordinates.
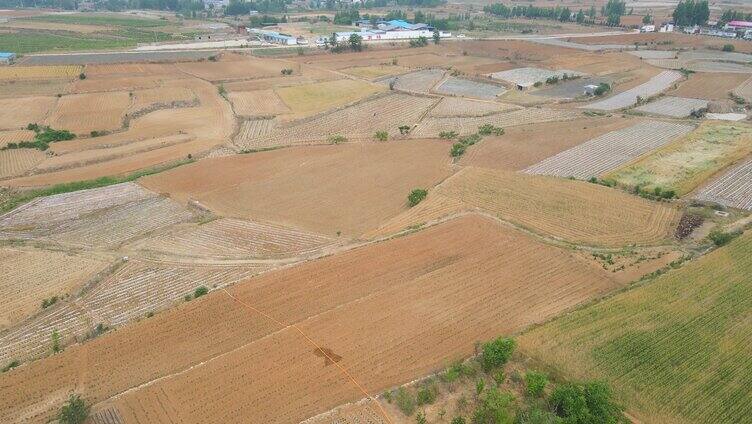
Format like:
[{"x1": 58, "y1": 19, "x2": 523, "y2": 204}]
[{"x1": 141, "y1": 140, "x2": 451, "y2": 235}]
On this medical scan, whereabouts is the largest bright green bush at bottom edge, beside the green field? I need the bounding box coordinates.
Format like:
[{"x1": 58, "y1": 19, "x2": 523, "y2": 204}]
[{"x1": 549, "y1": 382, "x2": 625, "y2": 424}]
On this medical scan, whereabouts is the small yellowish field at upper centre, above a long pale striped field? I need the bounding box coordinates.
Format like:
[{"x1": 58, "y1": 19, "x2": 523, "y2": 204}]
[{"x1": 276, "y1": 79, "x2": 387, "y2": 117}]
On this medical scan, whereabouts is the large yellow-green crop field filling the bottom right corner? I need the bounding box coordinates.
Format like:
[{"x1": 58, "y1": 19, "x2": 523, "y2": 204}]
[{"x1": 518, "y1": 234, "x2": 752, "y2": 424}]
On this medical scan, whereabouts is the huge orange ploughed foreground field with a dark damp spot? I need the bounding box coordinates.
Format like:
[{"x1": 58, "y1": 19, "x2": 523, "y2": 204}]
[{"x1": 0, "y1": 217, "x2": 619, "y2": 424}]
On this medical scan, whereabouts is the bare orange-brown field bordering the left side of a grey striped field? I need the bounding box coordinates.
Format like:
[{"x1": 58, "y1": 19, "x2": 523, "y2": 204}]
[{"x1": 460, "y1": 117, "x2": 634, "y2": 171}]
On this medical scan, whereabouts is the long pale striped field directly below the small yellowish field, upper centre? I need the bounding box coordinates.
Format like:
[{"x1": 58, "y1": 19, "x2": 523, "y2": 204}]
[{"x1": 236, "y1": 94, "x2": 437, "y2": 149}]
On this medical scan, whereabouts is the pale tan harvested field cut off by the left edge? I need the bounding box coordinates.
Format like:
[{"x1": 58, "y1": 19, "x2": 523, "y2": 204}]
[{"x1": 0, "y1": 248, "x2": 106, "y2": 330}]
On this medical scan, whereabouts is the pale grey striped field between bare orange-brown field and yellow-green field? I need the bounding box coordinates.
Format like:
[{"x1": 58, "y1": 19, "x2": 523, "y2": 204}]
[{"x1": 525, "y1": 121, "x2": 694, "y2": 180}]
